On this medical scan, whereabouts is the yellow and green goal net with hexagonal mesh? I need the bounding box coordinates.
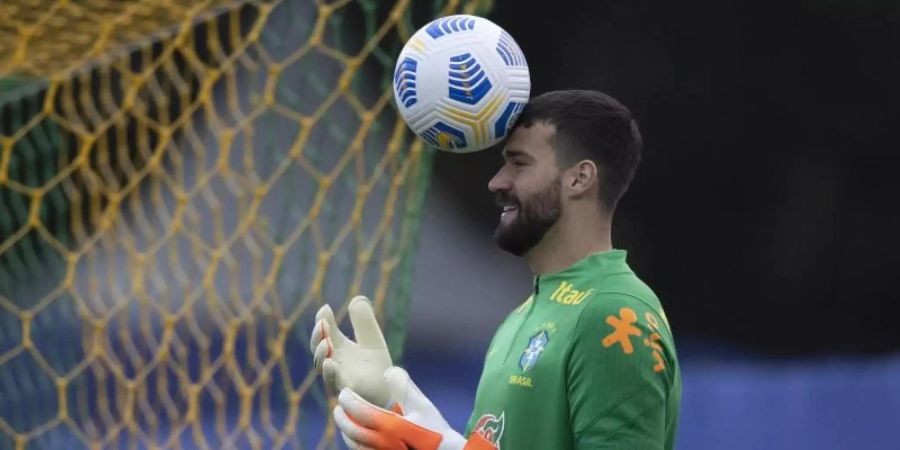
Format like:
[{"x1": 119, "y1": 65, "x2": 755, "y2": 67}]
[{"x1": 0, "y1": 0, "x2": 489, "y2": 449}]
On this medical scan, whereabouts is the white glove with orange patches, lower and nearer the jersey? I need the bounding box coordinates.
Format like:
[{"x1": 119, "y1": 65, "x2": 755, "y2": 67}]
[{"x1": 333, "y1": 367, "x2": 497, "y2": 450}]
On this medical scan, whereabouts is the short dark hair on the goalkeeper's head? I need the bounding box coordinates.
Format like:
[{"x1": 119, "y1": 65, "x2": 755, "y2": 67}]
[{"x1": 516, "y1": 90, "x2": 643, "y2": 212}]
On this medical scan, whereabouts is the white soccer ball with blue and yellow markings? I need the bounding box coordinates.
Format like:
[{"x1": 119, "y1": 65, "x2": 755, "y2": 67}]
[{"x1": 394, "y1": 15, "x2": 531, "y2": 153}]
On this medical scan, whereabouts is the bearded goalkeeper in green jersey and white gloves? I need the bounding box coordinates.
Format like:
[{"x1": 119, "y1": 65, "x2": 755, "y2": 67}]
[{"x1": 311, "y1": 91, "x2": 681, "y2": 450}]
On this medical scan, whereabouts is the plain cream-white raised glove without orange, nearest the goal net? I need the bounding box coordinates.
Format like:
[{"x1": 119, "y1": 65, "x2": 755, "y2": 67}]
[{"x1": 309, "y1": 295, "x2": 391, "y2": 405}]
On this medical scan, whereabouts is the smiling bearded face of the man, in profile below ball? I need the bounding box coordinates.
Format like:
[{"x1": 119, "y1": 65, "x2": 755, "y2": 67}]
[{"x1": 488, "y1": 122, "x2": 562, "y2": 256}]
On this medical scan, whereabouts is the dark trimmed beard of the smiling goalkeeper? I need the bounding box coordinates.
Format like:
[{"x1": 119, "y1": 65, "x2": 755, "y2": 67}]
[{"x1": 494, "y1": 177, "x2": 562, "y2": 256}]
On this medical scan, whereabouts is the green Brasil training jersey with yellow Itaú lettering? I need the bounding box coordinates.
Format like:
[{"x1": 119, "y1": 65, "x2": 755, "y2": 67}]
[{"x1": 466, "y1": 250, "x2": 681, "y2": 450}]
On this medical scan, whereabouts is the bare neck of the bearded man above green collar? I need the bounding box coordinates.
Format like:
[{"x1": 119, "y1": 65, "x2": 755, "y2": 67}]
[{"x1": 525, "y1": 203, "x2": 612, "y2": 276}]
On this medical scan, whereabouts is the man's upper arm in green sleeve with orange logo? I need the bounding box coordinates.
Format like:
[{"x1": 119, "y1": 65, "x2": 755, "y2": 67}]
[{"x1": 568, "y1": 294, "x2": 671, "y2": 450}]
